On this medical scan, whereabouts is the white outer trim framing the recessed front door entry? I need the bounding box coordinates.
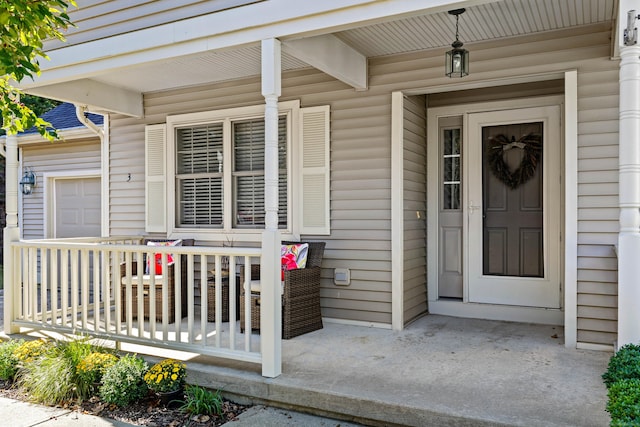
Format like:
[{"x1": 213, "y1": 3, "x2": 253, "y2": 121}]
[{"x1": 391, "y1": 69, "x2": 578, "y2": 348}]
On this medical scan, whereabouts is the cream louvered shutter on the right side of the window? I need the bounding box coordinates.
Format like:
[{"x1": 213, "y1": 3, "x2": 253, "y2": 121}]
[{"x1": 299, "y1": 105, "x2": 331, "y2": 235}]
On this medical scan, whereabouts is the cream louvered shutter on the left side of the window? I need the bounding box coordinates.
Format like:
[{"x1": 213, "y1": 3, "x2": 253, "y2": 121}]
[{"x1": 144, "y1": 123, "x2": 167, "y2": 233}]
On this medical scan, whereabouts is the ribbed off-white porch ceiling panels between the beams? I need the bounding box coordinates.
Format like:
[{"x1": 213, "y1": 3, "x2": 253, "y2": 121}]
[{"x1": 25, "y1": 0, "x2": 617, "y2": 115}]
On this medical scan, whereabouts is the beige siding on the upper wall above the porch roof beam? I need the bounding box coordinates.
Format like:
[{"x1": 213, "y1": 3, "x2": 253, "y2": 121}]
[{"x1": 45, "y1": 0, "x2": 261, "y2": 50}]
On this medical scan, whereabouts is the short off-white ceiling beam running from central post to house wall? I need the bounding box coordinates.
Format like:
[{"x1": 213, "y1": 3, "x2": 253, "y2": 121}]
[{"x1": 282, "y1": 34, "x2": 367, "y2": 90}]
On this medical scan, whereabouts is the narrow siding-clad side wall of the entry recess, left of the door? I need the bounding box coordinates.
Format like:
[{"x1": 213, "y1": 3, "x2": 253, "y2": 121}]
[{"x1": 403, "y1": 96, "x2": 427, "y2": 324}]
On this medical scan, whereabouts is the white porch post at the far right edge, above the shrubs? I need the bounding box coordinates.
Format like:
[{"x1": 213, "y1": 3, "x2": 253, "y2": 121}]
[{"x1": 617, "y1": 1, "x2": 640, "y2": 347}]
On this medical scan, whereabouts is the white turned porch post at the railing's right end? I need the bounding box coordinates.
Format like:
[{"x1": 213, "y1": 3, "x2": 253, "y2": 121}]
[{"x1": 260, "y1": 39, "x2": 282, "y2": 378}]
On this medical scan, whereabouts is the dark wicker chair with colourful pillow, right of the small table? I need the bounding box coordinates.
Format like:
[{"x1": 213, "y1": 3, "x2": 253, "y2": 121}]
[{"x1": 240, "y1": 242, "x2": 325, "y2": 339}]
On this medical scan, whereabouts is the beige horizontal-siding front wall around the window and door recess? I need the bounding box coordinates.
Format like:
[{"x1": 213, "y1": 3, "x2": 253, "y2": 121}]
[{"x1": 110, "y1": 25, "x2": 618, "y2": 344}]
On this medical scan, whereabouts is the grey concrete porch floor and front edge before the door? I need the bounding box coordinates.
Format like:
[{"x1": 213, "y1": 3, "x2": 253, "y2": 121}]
[{"x1": 181, "y1": 315, "x2": 611, "y2": 426}]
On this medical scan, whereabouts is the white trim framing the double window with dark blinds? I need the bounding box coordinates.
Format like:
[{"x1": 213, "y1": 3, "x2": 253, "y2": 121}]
[{"x1": 166, "y1": 100, "x2": 301, "y2": 242}]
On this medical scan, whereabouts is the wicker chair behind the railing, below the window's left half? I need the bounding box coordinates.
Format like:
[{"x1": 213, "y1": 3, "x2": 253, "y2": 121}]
[{"x1": 120, "y1": 239, "x2": 194, "y2": 323}]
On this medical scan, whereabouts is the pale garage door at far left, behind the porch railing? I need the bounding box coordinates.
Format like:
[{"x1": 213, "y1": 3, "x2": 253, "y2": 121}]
[{"x1": 55, "y1": 178, "x2": 102, "y2": 238}]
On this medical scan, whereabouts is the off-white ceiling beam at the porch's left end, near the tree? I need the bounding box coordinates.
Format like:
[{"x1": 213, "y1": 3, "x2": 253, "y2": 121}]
[{"x1": 25, "y1": 79, "x2": 144, "y2": 118}]
